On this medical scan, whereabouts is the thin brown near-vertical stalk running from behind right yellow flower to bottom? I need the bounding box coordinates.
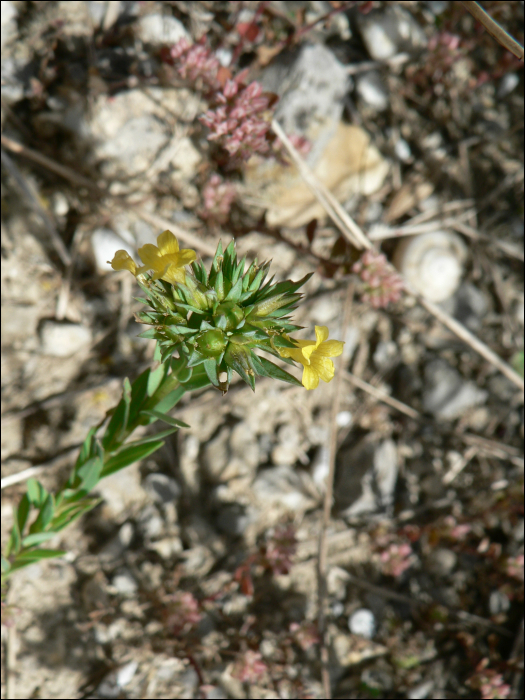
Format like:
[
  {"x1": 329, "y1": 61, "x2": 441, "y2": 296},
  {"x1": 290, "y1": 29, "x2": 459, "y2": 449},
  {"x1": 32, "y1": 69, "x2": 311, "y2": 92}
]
[{"x1": 317, "y1": 283, "x2": 354, "y2": 698}]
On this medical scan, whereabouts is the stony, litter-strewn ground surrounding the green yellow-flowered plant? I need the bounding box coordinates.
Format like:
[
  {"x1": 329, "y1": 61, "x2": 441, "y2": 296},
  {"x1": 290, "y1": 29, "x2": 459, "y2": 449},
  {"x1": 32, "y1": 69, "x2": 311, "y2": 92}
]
[{"x1": 2, "y1": 2, "x2": 524, "y2": 698}]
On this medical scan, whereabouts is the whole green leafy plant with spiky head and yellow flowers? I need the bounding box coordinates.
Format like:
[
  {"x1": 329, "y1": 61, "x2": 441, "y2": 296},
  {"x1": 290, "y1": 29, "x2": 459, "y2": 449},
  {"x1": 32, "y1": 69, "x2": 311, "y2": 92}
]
[{"x1": 2, "y1": 231, "x2": 344, "y2": 581}]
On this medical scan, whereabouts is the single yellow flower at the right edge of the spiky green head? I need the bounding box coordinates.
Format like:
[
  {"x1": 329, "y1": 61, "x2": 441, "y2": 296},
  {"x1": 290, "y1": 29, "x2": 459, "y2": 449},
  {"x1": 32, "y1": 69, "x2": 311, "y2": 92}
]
[{"x1": 279, "y1": 326, "x2": 344, "y2": 389}]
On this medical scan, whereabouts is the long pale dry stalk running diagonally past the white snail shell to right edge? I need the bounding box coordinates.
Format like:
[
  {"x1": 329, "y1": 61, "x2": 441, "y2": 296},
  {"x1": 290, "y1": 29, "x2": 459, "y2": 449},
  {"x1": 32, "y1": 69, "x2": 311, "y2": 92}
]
[{"x1": 272, "y1": 119, "x2": 525, "y2": 391}]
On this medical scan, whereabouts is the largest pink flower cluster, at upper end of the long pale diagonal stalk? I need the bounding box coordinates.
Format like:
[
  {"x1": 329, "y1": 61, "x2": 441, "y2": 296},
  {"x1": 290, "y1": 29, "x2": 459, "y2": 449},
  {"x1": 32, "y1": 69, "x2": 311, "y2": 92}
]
[{"x1": 199, "y1": 71, "x2": 271, "y2": 161}]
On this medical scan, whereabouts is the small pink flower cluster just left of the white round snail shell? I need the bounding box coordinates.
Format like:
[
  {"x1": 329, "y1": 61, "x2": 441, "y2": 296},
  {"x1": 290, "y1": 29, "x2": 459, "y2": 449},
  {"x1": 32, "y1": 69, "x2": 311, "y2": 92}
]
[{"x1": 352, "y1": 250, "x2": 404, "y2": 309}]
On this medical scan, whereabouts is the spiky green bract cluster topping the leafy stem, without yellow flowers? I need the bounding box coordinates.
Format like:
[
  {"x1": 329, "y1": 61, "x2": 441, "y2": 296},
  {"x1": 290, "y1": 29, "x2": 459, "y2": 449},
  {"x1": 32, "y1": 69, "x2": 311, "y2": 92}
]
[{"x1": 136, "y1": 241, "x2": 311, "y2": 392}]
